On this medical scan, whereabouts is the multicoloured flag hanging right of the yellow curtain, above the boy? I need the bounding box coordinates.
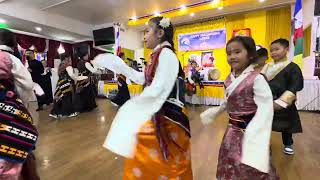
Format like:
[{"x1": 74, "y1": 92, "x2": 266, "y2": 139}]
[{"x1": 293, "y1": 0, "x2": 303, "y2": 68}]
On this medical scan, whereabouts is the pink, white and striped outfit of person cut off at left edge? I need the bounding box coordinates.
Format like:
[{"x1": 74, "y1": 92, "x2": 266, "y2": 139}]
[{"x1": 0, "y1": 51, "x2": 38, "y2": 180}]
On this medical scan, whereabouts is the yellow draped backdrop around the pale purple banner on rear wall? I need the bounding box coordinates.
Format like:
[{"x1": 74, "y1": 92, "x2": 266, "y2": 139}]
[{"x1": 172, "y1": 6, "x2": 291, "y2": 80}]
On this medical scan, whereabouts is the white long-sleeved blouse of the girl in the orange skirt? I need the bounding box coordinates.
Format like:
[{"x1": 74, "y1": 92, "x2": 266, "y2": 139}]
[{"x1": 93, "y1": 42, "x2": 179, "y2": 158}]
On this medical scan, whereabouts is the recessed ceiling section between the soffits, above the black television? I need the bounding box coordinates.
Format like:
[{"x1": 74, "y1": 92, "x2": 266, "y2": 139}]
[{"x1": 12, "y1": 0, "x2": 201, "y2": 25}]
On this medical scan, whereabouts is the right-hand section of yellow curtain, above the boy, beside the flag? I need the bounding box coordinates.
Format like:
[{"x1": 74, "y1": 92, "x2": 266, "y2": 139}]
[{"x1": 265, "y1": 6, "x2": 291, "y2": 48}]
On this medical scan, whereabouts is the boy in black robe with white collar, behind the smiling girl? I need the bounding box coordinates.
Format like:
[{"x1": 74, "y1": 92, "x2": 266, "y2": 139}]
[{"x1": 262, "y1": 39, "x2": 303, "y2": 155}]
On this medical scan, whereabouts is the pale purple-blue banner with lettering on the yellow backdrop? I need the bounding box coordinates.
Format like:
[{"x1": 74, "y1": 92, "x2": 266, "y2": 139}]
[{"x1": 178, "y1": 29, "x2": 226, "y2": 51}]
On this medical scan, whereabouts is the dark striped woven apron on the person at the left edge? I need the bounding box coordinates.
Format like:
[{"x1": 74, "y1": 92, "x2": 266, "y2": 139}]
[{"x1": 0, "y1": 81, "x2": 38, "y2": 163}]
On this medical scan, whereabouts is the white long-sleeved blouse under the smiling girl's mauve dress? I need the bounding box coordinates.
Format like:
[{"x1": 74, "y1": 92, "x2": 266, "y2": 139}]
[{"x1": 200, "y1": 66, "x2": 274, "y2": 173}]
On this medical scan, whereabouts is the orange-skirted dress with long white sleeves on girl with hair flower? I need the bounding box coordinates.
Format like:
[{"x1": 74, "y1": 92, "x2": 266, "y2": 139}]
[{"x1": 93, "y1": 42, "x2": 192, "y2": 180}]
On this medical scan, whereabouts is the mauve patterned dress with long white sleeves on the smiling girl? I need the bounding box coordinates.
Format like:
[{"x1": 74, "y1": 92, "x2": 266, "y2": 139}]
[{"x1": 201, "y1": 65, "x2": 279, "y2": 180}]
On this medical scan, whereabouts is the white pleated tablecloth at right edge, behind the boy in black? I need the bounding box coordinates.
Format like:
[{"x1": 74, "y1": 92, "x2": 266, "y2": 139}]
[{"x1": 296, "y1": 80, "x2": 320, "y2": 111}]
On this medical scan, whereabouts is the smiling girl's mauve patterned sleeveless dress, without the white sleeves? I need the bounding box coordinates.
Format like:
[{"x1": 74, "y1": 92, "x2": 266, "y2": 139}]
[{"x1": 217, "y1": 72, "x2": 279, "y2": 180}]
